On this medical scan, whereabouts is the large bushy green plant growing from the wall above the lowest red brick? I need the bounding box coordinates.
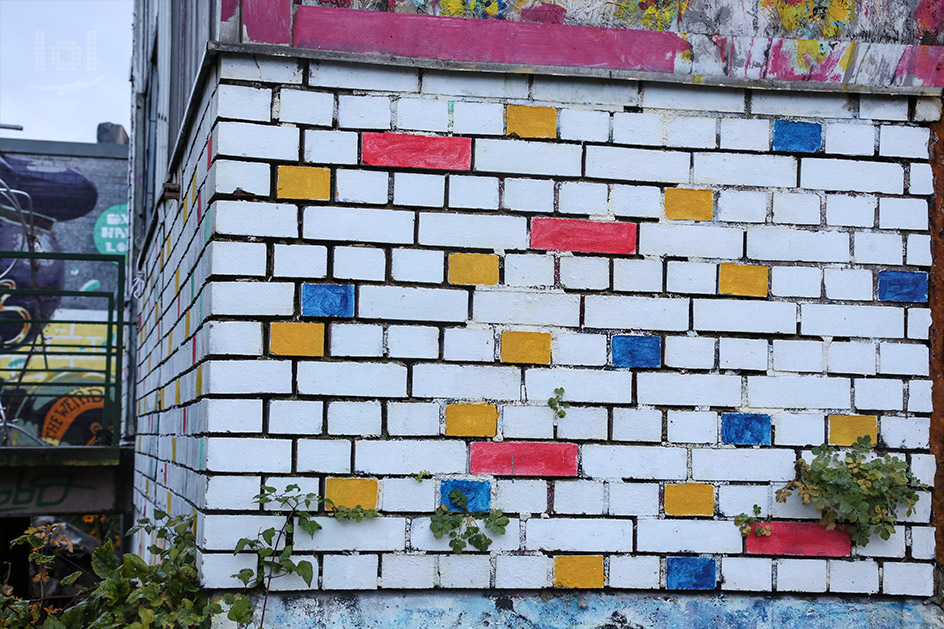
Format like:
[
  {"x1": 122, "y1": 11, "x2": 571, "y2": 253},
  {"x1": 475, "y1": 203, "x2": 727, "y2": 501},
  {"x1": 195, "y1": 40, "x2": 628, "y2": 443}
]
[{"x1": 777, "y1": 436, "x2": 929, "y2": 546}]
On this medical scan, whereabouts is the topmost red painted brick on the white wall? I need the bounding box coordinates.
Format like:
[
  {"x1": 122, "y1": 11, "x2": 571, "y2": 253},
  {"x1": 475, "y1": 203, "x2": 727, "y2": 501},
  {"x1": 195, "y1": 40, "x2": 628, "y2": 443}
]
[{"x1": 362, "y1": 133, "x2": 472, "y2": 170}]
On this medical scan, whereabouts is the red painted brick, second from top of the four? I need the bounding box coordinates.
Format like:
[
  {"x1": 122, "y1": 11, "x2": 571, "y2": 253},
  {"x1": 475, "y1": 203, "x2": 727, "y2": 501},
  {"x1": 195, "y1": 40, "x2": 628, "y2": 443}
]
[{"x1": 531, "y1": 218, "x2": 636, "y2": 254}]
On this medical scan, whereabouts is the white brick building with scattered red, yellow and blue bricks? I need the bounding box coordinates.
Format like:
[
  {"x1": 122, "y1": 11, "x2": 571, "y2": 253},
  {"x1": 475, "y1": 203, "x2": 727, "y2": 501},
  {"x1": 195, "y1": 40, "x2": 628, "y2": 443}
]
[{"x1": 131, "y1": 0, "x2": 944, "y2": 627}]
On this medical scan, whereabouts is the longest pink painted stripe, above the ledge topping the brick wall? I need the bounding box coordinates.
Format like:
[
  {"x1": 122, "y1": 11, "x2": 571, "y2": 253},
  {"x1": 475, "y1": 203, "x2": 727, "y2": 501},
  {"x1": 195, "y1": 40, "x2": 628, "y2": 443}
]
[{"x1": 292, "y1": 6, "x2": 691, "y2": 73}]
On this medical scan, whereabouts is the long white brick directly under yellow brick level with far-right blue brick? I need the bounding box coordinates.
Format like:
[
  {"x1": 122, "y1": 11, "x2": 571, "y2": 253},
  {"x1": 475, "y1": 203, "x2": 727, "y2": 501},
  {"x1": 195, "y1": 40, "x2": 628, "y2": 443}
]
[{"x1": 692, "y1": 299, "x2": 797, "y2": 334}]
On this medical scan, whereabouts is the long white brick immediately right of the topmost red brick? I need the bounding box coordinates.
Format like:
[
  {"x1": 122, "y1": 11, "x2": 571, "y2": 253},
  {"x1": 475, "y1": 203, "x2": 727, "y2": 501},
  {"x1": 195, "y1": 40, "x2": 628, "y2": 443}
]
[{"x1": 475, "y1": 139, "x2": 581, "y2": 177}]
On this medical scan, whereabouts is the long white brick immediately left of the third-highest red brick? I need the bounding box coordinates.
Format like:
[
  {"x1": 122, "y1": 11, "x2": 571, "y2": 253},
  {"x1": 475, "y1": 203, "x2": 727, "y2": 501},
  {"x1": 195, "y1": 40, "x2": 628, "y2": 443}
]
[{"x1": 354, "y1": 440, "x2": 467, "y2": 480}]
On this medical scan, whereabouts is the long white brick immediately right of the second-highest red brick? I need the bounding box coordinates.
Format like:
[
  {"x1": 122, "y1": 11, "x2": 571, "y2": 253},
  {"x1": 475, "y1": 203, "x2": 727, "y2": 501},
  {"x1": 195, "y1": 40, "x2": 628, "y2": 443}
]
[{"x1": 639, "y1": 223, "x2": 744, "y2": 259}]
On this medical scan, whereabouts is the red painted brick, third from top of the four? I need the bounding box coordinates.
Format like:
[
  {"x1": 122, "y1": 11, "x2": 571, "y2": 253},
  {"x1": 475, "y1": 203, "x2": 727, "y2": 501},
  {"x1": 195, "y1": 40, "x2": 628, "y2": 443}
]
[{"x1": 469, "y1": 441, "x2": 577, "y2": 476}]
